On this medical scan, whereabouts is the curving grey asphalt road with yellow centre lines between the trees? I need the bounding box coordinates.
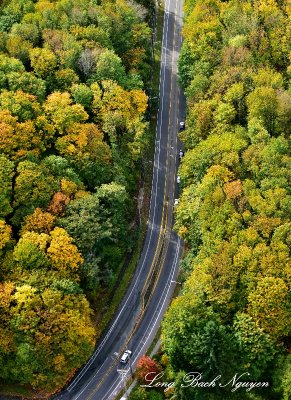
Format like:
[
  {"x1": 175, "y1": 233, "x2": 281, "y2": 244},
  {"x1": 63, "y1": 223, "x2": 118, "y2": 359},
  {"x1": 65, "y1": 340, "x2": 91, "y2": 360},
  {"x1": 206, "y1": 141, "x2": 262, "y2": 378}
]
[{"x1": 55, "y1": 0, "x2": 185, "y2": 400}]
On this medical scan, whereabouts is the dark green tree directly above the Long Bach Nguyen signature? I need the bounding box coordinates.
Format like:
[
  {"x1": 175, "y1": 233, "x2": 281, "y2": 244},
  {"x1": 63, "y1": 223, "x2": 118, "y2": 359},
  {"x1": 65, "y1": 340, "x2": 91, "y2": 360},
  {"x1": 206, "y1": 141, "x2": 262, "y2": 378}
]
[{"x1": 162, "y1": 293, "x2": 236, "y2": 379}]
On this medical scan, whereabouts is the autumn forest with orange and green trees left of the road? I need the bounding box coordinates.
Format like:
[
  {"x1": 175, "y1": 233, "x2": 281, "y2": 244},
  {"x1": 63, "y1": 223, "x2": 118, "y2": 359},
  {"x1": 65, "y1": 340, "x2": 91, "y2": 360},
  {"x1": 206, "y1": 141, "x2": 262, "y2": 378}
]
[{"x1": 0, "y1": 0, "x2": 155, "y2": 397}]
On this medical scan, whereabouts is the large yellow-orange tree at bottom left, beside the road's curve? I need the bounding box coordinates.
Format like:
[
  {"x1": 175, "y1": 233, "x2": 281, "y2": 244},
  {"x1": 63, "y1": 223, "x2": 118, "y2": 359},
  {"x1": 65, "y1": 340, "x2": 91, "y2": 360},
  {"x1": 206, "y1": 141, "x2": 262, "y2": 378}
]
[{"x1": 5, "y1": 285, "x2": 95, "y2": 390}]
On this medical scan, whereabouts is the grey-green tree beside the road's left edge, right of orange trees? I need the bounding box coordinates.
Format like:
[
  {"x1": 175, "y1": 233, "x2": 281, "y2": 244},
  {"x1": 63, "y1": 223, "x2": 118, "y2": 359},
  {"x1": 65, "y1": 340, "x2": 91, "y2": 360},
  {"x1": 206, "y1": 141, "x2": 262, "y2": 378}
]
[{"x1": 60, "y1": 183, "x2": 127, "y2": 290}]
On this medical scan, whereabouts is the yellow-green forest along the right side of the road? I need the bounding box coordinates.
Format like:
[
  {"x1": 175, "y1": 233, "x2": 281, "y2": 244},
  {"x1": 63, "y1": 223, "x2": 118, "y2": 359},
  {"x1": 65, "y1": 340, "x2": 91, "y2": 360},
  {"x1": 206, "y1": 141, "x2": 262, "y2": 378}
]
[{"x1": 131, "y1": 0, "x2": 291, "y2": 400}]
